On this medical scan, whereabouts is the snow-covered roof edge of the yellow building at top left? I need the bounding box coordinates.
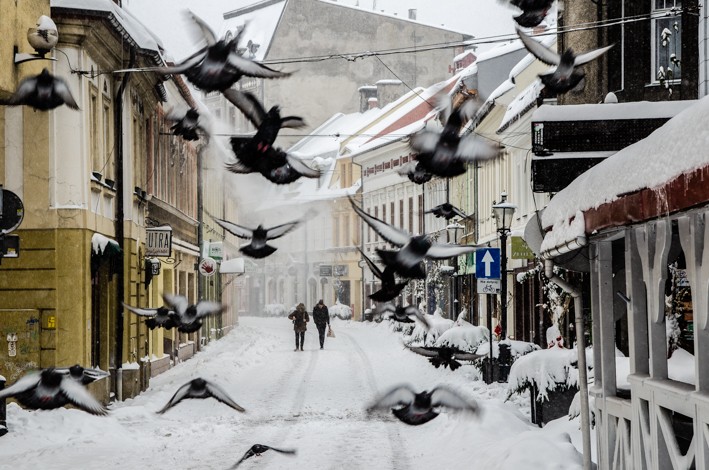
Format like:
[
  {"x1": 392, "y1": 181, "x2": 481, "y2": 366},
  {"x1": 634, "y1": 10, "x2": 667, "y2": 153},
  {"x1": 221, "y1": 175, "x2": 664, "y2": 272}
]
[{"x1": 50, "y1": 0, "x2": 164, "y2": 58}]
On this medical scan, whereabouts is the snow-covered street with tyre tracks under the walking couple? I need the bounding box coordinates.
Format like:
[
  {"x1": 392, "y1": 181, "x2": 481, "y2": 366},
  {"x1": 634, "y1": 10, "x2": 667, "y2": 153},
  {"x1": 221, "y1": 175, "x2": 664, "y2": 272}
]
[{"x1": 0, "y1": 317, "x2": 580, "y2": 470}]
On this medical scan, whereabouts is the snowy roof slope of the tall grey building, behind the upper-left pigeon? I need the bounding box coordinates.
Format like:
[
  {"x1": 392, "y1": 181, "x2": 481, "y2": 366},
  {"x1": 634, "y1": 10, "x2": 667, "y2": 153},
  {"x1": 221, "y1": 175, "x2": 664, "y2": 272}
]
[{"x1": 221, "y1": 0, "x2": 286, "y2": 60}]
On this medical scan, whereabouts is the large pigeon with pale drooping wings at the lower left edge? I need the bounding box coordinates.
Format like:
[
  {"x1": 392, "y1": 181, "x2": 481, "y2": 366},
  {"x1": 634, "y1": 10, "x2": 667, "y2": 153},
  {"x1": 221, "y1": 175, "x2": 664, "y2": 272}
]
[{"x1": 0, "y1": 368, "x2": 108, "y2": 415}]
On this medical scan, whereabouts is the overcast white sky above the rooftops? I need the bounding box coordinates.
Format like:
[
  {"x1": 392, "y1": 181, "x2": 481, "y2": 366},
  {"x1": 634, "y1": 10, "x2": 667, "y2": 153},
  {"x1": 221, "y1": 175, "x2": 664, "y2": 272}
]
[{"x1": 123, "y1": 0, "x2": 514, "y2": 60}]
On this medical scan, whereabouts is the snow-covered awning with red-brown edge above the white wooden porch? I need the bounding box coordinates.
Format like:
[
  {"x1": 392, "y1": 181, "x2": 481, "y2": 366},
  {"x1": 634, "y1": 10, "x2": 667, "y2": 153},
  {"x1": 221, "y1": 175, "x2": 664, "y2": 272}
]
[{"x1": 542, "y1": 97, "x2": 709, "y2": 249}]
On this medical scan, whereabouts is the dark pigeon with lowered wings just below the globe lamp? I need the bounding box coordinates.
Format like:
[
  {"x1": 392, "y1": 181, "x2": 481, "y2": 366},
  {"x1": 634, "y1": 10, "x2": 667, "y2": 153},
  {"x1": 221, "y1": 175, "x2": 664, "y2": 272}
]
[{"x1": 0, "y1": 69, "x2": 79, "y2": 111}]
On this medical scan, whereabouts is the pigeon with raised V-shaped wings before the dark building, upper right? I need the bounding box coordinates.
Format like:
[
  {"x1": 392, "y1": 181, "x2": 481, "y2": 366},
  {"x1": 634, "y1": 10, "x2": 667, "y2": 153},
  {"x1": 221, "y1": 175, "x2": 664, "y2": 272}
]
[{"x1": 517, "y1": 29, "x2": 613, "y2": 93}]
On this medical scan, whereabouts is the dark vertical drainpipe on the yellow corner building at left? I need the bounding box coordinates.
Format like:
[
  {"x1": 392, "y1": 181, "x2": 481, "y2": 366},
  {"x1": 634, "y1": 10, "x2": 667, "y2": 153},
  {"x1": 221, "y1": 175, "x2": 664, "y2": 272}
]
[{"x1": 113, "y1": 47, "x2": 136, "y2": 401}]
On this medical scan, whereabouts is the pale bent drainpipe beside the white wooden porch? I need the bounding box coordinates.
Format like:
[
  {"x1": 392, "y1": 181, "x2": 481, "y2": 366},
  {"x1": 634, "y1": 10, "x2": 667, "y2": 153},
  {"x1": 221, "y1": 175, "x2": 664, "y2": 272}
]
[{"x1": 544, "y1": 259, "x2": 592, "y2": 470}]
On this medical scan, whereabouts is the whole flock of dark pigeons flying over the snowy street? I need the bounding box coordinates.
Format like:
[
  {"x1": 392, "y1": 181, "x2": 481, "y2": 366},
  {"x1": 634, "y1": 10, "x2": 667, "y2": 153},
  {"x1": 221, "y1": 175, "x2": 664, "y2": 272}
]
[{"x1": 0, "y1": 0, "x2": 612, "y2": 467}]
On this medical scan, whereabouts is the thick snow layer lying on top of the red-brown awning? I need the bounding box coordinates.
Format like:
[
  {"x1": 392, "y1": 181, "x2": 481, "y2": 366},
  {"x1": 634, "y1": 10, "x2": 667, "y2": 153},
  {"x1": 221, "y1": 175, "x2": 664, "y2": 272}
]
[{"x1": 542, "y1": 97, "x2": 709, "y2": 241}]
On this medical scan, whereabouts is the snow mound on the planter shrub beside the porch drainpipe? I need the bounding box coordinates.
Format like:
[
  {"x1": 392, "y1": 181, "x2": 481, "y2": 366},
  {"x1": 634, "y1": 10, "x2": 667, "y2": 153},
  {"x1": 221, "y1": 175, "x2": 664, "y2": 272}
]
[{"x1": 507, "y1": 348, "x2": 578, "y2": 401}]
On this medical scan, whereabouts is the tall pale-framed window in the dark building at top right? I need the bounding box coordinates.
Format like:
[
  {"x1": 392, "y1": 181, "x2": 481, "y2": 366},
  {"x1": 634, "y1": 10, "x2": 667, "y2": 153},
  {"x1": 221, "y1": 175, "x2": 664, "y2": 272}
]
[{"x1": 652, "y1": 0, "x2": 682, "y2": 84}]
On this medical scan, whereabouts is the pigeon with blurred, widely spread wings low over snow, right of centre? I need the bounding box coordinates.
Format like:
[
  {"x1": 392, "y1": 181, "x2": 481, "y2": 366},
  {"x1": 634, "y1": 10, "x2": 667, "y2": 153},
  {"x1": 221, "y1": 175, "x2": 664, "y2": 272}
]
[{"x1": 367, "y1": 385, "x2": 479, "y2": 426}]
